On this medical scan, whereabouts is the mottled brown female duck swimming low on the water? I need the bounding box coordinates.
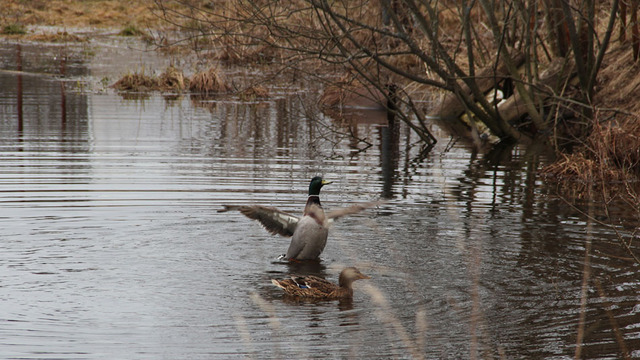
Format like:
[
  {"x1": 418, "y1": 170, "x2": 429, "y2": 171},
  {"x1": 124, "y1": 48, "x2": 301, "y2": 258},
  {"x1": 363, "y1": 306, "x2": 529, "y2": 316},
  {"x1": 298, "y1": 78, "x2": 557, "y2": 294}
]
[{"x1": 271, "y1": 267, "x2": 371, "y2": 300}]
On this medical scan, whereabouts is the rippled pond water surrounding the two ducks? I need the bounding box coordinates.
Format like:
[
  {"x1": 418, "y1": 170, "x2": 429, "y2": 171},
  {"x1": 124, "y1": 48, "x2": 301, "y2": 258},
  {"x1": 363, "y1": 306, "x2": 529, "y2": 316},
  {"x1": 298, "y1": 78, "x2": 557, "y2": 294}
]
[{"x1": 0, "y1": 40, "x2": 640, "y2": 359}]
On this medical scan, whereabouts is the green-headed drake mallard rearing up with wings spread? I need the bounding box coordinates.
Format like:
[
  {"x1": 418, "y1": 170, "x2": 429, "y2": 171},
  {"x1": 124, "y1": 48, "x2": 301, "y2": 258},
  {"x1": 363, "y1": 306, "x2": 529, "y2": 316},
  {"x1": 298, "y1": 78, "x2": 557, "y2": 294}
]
[{"x1": 218, "y1": 176, "x2": 376, "y2": 260}]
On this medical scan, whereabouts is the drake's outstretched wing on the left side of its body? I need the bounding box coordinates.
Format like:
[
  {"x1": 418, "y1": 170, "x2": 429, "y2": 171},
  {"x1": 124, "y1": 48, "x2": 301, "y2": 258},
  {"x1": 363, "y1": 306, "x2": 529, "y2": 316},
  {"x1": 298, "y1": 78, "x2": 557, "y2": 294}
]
[{"x1": 218, "y1": 205, "x2": 300, "y2": 236}]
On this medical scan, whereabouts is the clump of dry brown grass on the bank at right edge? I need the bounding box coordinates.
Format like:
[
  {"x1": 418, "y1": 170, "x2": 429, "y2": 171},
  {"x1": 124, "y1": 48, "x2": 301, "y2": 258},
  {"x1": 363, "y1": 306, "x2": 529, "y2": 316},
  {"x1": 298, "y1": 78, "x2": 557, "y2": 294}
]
[{"x1": 545, "y1": 44, "x2": 640, "y2": 196}]
